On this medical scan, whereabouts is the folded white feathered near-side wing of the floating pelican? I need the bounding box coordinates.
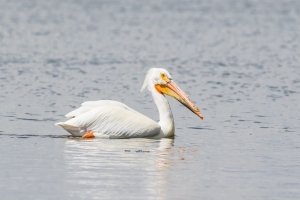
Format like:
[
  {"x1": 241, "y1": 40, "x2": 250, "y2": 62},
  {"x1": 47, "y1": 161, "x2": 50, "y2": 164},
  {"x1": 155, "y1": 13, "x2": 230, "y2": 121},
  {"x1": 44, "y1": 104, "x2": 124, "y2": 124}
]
[{"x1": 58, "y1": 102, "x2": 160, "y2": 138}]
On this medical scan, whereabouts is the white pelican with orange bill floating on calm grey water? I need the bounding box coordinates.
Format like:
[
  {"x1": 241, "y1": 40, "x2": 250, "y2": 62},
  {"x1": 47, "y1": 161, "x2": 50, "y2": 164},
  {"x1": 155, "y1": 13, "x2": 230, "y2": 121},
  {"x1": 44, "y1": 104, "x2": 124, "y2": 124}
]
[{"x1": 56, "y1": 68, "x2": 204, "y2": 138}]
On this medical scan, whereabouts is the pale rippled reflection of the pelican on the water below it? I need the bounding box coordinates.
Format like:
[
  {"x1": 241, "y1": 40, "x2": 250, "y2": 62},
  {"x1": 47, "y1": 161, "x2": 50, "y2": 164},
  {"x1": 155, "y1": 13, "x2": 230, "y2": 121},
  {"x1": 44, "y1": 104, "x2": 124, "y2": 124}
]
[{"x1": 64, "y1": 138, "x2": 174, "y2": 199}]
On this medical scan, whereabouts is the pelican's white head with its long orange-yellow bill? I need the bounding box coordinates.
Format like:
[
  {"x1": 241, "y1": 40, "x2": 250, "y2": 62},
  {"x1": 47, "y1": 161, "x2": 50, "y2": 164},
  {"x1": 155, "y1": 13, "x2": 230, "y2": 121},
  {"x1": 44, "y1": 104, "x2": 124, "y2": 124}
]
[{"x1": 141, "y1": 68, "x2": 204, "y2": 120}]
